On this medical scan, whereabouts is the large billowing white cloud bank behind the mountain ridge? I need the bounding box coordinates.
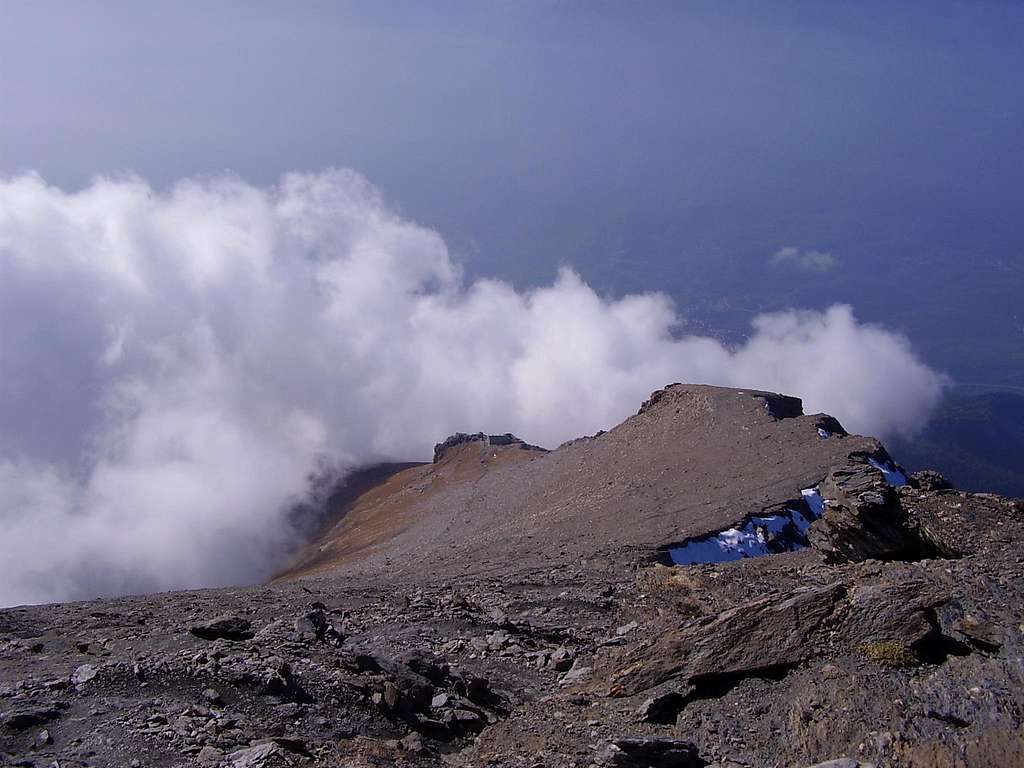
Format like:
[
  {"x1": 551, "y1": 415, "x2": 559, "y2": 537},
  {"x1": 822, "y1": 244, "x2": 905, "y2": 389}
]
[{"x1": 0, "y1": 170, "x2": 942, "y2": 604}]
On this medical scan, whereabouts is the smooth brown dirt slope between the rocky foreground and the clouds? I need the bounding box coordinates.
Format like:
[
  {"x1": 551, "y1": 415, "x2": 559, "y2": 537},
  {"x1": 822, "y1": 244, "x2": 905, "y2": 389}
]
[{"x1": 288, "y1": 385, "x2": 884, "y2": 575}]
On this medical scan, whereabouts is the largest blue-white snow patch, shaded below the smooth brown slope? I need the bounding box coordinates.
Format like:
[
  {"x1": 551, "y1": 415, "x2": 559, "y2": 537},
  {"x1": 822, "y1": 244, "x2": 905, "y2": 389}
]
[{"x1": 669, "y1": 487, "x2": 825, "y2": 565}]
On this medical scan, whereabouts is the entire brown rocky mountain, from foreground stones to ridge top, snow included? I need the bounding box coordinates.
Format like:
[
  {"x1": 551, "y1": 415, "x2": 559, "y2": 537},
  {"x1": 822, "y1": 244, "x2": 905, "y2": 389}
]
[{"x1": 0, "y1": 385, "x2": 1024, "y2": 768}]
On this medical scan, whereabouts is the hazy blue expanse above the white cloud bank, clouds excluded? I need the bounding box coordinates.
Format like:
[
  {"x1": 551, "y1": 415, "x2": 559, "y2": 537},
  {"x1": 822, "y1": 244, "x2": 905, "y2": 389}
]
[{"x1": 0, "y1": 1, "x2": 1024, "y2": 380}]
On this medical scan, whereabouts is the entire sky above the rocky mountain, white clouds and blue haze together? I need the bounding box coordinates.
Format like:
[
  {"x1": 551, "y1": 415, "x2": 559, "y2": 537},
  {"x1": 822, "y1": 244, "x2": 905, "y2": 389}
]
[{"x1": 0, "y1": 2, "x2": 1024, "y2": 604}]
